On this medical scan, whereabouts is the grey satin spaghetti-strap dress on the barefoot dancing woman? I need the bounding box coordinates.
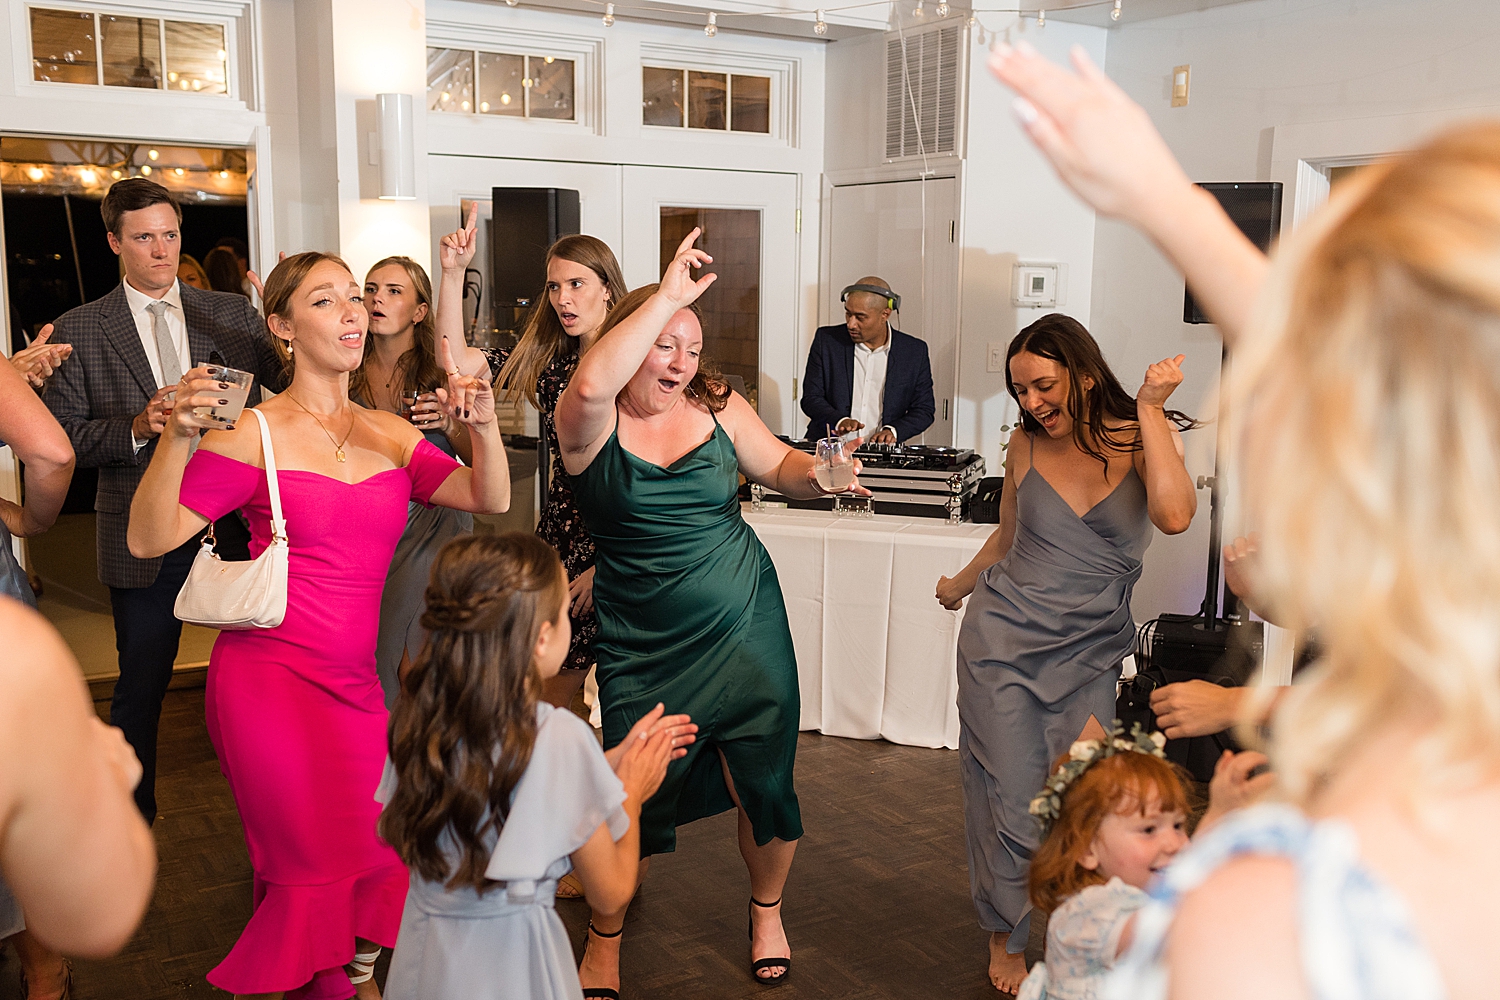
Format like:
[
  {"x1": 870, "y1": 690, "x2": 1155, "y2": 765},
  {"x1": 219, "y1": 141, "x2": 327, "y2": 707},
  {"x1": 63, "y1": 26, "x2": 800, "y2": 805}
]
[{"x1": 959, "y1": 446, "x2": 1152, "y2": 952}]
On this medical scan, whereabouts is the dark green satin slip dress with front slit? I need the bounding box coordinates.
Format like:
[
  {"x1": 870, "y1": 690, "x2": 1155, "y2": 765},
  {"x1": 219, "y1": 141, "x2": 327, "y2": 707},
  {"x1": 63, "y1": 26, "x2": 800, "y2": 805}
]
[{"x1": 570, "y1": 420, "x2": 803, "y2": 855}]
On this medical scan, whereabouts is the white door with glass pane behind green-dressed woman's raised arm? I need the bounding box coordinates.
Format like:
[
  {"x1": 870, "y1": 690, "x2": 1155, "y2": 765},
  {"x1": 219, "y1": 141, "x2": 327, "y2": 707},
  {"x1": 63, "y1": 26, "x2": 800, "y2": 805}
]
[{"x1": 620, "y1": 166, "x2": 801, "y2": 435}]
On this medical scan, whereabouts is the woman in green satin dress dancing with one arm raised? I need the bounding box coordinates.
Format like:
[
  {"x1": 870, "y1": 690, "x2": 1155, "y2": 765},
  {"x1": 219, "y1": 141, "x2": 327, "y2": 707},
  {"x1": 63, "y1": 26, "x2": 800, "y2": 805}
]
[{"x1": 557, "y1": 229, "x2": 866, "y2": 997}]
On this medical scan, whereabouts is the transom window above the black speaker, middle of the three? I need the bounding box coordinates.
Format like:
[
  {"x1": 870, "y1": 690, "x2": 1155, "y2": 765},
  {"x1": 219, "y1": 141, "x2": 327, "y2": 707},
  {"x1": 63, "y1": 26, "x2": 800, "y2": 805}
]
[{"x1": 428, "y1": 46, "x2": 575, "y2": 121}]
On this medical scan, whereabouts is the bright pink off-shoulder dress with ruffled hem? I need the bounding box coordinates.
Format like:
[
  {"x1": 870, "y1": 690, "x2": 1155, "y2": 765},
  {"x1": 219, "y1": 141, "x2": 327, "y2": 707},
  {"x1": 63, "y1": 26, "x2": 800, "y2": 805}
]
[{"x1": 180, "y1": 441, "x2": 459, "y2": 1000}]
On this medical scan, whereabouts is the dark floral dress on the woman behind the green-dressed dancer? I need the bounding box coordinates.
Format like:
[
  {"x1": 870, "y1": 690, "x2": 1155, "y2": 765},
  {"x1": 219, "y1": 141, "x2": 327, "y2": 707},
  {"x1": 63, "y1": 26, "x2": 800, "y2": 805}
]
[{"x1": 498, "y1": 351, "x2": 599, "y2": 670}]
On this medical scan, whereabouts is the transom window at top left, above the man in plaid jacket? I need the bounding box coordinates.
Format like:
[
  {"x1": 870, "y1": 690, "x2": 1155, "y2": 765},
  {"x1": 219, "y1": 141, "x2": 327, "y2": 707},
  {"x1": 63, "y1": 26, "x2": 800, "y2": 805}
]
[{"x1": 32, "y1": 7, "x2": 230, "y2": 96}]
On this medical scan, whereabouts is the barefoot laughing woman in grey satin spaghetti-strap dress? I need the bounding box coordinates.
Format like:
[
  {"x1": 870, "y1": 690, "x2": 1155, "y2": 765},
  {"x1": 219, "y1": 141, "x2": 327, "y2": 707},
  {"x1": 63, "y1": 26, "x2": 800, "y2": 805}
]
[{"x1": 938, "y1": 313, "x2": 1197, "y2": 993}]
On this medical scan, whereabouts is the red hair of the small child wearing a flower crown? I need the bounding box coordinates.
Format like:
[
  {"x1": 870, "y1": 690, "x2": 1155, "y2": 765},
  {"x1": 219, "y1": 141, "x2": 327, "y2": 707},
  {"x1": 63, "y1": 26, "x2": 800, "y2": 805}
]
[{"x1": 1028, "y1": 753, "x2": 1190, "y2": 913}]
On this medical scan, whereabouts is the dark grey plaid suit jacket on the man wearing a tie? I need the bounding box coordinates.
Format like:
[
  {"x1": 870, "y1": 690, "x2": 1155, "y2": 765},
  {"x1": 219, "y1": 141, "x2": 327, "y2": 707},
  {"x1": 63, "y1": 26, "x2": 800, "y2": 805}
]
[{"x1": 45, "y1": 285, "x2": 285, "y2": 588}]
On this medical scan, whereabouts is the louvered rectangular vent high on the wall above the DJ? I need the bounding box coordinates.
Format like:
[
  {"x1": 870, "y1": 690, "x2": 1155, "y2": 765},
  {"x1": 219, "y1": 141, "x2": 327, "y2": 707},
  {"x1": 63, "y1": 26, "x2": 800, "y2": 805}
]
[{"x1": 885, "y1": 24, "x2": 965, "y2": 160}]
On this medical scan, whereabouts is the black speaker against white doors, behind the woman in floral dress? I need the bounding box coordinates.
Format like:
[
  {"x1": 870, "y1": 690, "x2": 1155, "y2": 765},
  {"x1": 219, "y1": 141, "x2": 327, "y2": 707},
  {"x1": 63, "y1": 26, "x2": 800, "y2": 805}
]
[{"x1": 489, "y1": 187, "x2": 579, "y2": 309}]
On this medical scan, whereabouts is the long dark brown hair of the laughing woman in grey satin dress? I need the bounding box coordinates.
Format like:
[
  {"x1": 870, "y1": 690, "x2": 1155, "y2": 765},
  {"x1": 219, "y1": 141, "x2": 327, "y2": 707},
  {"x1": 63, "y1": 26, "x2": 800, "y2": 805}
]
[{"x1": 1005, "y1": 319, "x2": 1202, "y2": 475}]
